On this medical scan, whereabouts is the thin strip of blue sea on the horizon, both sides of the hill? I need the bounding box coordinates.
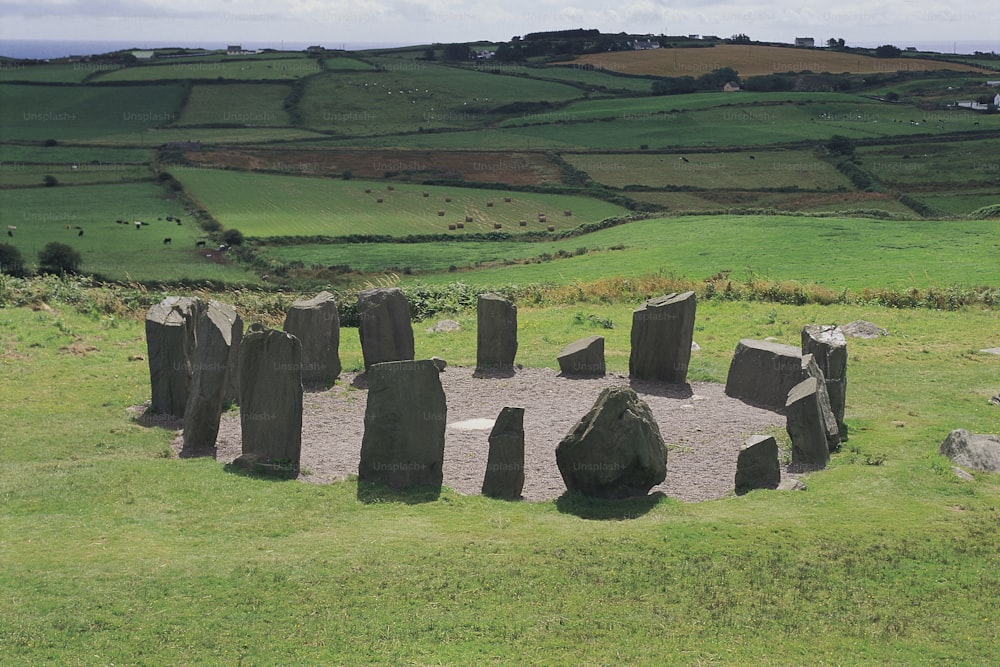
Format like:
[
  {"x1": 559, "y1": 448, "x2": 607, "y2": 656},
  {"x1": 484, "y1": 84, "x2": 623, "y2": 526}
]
[{"x1": 0, "y1": 39, "x2": 1000, "y2": 60}]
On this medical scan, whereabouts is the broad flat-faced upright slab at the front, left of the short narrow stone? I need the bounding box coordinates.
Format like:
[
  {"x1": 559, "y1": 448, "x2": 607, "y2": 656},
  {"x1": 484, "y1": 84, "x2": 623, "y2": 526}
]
[{"x1": 358, "y1": 359, "x2": 448, "y2": 489}]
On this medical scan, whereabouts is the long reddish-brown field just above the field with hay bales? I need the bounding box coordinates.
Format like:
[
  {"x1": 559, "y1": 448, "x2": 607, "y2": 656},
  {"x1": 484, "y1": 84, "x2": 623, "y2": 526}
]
[{"x1": 186, "y1": 149, "x2": 561, "y2": 185}]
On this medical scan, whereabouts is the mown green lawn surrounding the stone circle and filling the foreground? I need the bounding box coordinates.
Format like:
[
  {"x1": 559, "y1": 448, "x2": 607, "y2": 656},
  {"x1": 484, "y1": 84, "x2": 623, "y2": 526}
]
[{"x1": 0, "y1": 294, "x2": 1000, "y2": 665}]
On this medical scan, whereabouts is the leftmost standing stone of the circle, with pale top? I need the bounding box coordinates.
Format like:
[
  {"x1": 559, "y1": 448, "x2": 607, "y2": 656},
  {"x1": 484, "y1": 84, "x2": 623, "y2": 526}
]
[{"x1": 146, "y1": 296, "x2": 195, "y2": 417}]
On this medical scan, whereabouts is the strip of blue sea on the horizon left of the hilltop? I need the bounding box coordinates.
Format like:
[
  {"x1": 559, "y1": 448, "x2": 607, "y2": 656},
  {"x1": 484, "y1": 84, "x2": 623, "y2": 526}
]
[{"x1": 0, "y1": 39, "x2": 406, "y2": 60}]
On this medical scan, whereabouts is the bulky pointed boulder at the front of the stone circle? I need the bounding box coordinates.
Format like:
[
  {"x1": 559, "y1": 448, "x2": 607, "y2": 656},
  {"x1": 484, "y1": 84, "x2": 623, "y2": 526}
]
[{"x1": 556, "y1": 386, "x2": 667, "y2": 498}]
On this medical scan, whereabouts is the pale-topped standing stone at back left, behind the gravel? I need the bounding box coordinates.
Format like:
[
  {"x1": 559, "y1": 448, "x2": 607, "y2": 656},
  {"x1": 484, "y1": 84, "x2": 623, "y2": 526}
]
[{"x1": 284, "y1": 291, "x2": 341, "y2": 386}]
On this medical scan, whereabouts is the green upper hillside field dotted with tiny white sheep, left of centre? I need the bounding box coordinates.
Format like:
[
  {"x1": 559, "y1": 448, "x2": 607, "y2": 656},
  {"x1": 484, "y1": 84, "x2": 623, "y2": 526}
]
[{"x1": 300, "y1": 67, "x2": 582, "y2": 136}]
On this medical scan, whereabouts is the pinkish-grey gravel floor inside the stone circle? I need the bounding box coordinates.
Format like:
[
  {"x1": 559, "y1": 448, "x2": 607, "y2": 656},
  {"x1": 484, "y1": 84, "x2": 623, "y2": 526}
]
[{"x1": 186, "y1": 366, "x2": 787, "y2": 502}]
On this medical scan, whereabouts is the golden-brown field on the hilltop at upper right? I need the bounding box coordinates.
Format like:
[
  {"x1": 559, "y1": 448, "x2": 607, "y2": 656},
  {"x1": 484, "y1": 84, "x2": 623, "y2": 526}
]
[{"x1": 573, "y1": 44, "x2": 979, "y2": 77}]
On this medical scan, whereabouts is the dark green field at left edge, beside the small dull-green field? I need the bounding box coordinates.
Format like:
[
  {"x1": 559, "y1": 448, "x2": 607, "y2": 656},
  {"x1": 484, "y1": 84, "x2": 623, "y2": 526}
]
[{"x1": 0, "y1": 84, "x2": 184, "y2": 141}]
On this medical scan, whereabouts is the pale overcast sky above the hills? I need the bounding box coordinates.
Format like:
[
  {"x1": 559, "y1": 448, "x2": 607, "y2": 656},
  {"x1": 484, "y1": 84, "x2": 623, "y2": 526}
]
[{"x1": 0, "y1": 0, "x2": 1000, "y2": 51}]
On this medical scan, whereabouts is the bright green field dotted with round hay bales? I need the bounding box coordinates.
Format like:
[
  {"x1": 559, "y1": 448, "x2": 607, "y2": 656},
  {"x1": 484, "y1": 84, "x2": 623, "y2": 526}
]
[{"x1": 171, "y1": 168, "x2": 626, "y2": 237}]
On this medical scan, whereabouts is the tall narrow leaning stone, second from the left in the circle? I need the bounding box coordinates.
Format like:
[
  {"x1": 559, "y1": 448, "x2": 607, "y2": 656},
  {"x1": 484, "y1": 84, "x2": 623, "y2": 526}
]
[{"x1": 184, "y1": 299, "x2": 237, "y2": 455}]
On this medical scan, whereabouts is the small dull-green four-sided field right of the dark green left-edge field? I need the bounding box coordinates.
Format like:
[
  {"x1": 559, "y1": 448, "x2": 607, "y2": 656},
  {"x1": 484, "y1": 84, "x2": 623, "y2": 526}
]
[{"x1": 175, "y1": 84, "x2": 291, "y2": 126}]
